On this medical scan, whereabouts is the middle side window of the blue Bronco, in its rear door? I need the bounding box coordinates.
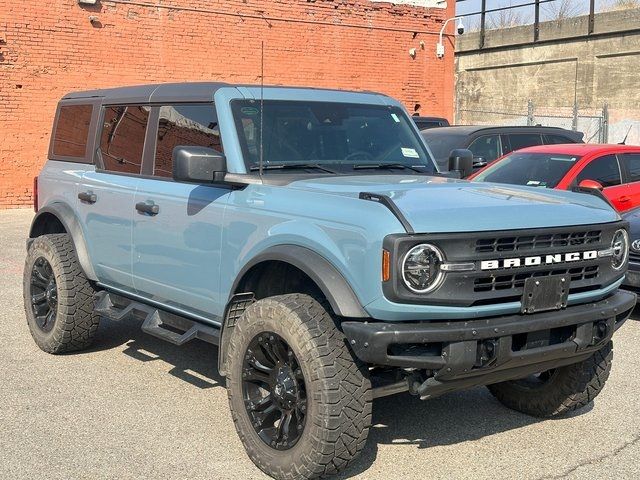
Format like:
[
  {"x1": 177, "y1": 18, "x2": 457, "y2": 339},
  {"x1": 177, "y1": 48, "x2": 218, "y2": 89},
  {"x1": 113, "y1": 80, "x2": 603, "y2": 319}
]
[{"x1": 100, "y1": 105, "x2": 150, "y2": 174}]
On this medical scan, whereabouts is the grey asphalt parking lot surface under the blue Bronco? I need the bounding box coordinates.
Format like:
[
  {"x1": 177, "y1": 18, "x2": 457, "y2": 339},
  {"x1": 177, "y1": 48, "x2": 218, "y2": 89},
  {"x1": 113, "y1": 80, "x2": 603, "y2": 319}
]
[{"x1": 0, "y1": 210, "x2": 640, "y2": 479}]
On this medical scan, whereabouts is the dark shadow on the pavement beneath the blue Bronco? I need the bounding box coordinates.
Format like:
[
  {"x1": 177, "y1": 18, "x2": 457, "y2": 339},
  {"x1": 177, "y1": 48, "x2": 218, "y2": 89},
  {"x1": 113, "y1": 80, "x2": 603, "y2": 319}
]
[{"x1": 80, "y1": 316, "x2": 600, "y2": 478}]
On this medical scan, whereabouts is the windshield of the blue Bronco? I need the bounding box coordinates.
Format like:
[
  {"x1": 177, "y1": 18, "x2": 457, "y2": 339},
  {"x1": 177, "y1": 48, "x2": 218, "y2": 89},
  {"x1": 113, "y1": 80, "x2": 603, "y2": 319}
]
[{"x1": 231, "y1": 100, "x2": 436, "y2": 174}]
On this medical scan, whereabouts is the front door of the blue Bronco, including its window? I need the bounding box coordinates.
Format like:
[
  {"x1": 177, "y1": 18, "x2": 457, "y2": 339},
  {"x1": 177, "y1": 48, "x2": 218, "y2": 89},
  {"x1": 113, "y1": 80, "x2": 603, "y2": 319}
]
[{"x1": 131, "y1": 103, "x2": 231, "y2": 318}]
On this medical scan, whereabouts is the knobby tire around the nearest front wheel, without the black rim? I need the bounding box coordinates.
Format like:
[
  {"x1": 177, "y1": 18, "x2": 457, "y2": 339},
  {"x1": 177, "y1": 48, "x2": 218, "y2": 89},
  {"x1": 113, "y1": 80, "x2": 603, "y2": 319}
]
[{"x1": 227, "y1": 294, "x2": 372, "y2": 480}]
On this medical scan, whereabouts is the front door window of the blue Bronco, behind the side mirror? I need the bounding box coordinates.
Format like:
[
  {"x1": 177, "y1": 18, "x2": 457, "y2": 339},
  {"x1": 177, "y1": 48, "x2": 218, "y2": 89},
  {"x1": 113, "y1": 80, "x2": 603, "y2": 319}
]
[{"x1": 153, "y1": 103, "x2": 222, "y2": 177}]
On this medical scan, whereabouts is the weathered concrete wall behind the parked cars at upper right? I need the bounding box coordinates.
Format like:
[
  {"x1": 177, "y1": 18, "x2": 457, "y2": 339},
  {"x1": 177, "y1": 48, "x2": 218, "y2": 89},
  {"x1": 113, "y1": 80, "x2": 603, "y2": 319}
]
[{"x1": 456, "y1": 9, "x2": 640, "y2": 144}]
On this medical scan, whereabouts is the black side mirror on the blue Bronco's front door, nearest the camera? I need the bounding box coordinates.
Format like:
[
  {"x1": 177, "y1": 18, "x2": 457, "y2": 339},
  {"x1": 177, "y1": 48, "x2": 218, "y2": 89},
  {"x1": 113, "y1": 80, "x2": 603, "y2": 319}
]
[{"x1": 171, "y1": 145, "x2": 227, "y2": 183}]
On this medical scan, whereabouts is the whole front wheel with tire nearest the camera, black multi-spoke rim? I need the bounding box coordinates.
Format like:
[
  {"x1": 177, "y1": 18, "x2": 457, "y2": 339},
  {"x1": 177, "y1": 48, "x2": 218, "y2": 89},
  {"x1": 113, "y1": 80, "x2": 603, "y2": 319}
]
[{"x1": 227, "y1": 294, "x2": 371, "y2": 479}]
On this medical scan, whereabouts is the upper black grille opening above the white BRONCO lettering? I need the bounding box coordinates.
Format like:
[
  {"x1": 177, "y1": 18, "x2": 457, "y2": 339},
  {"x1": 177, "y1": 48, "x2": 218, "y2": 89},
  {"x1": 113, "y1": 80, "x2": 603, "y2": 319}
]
[{"x1": 476, "y1": 230, "x2": 602, "y2": 253}]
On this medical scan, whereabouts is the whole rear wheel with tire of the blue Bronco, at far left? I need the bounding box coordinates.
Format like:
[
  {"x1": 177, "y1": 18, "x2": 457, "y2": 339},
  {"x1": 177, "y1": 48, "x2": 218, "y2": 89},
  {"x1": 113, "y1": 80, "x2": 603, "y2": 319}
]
[{"x1": 22, "y1": 234, "x2": 99, "y2": 353}]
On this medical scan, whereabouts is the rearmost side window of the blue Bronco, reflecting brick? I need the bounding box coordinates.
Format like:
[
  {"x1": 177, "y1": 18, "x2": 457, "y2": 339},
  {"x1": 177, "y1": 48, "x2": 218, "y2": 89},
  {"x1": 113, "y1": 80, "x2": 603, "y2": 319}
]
[{"x1": 53, "y1": 105, "x2": 93, "y2": 159}]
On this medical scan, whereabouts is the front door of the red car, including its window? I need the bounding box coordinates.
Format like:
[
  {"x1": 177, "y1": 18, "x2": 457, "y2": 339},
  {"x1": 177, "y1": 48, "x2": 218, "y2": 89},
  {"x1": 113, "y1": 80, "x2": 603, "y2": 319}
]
[{"x1": 573, "y1": 155, "x2": 631, "y2": 211}]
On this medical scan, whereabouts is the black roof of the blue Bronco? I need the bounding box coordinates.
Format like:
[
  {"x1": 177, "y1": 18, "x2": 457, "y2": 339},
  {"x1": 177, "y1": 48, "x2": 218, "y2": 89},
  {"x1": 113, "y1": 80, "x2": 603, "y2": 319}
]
[{"x1": 62, "y1": 82, "x2": 383, "y2": 103}]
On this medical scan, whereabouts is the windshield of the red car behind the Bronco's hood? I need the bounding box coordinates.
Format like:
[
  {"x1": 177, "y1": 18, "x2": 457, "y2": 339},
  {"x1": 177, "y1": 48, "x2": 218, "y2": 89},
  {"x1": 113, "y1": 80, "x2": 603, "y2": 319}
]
[{"x1": 471, "y1": 152, "x2": 580, "y2": 188}]
